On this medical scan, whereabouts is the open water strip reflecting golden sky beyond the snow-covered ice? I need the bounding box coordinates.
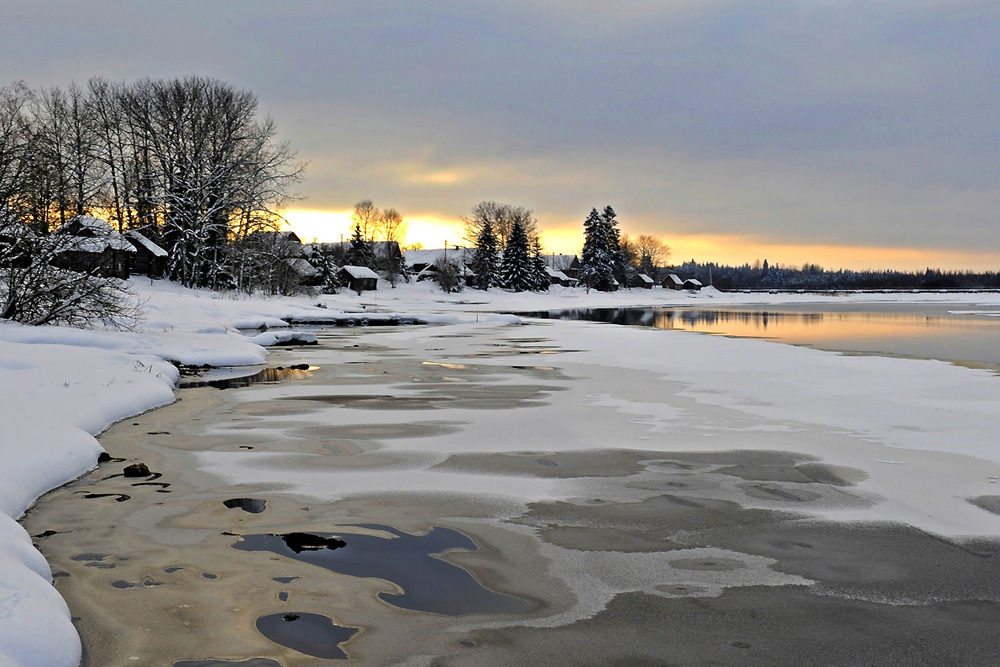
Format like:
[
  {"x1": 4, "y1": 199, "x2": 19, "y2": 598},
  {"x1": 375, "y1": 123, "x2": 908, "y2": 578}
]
[{"x1": 530, "y1": 306, "x2": 1000, "y2": 366}]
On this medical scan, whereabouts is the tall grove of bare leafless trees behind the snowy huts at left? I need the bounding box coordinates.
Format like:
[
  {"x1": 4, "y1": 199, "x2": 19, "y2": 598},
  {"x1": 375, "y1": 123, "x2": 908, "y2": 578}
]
[{"x1": 0, "y1": 76, "x2": 303, "y2": 324}]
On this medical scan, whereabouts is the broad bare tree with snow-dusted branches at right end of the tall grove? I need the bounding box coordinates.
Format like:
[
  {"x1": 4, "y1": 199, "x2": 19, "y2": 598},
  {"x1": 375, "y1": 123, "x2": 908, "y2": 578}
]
[{"x1": 117, "y1": 77, "x2": 303, "y2": 286}]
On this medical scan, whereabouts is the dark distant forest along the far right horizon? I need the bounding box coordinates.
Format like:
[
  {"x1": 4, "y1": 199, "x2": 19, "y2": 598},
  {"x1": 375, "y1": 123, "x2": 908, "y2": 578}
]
[{"x1": 667, "y1": 260, "x2": 1000, "y2": 291}]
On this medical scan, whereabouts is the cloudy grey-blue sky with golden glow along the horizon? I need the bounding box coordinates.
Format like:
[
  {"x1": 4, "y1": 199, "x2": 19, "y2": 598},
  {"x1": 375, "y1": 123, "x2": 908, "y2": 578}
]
[{"x1": 0, "y1": 0, "x2": 1000, "y2": 270}]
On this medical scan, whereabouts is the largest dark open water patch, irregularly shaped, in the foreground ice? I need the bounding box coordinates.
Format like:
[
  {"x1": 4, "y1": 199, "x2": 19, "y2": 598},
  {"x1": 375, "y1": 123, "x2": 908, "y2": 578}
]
[{"x1": 233, "y1": 524, "x2": 534, "y2": 616}]
